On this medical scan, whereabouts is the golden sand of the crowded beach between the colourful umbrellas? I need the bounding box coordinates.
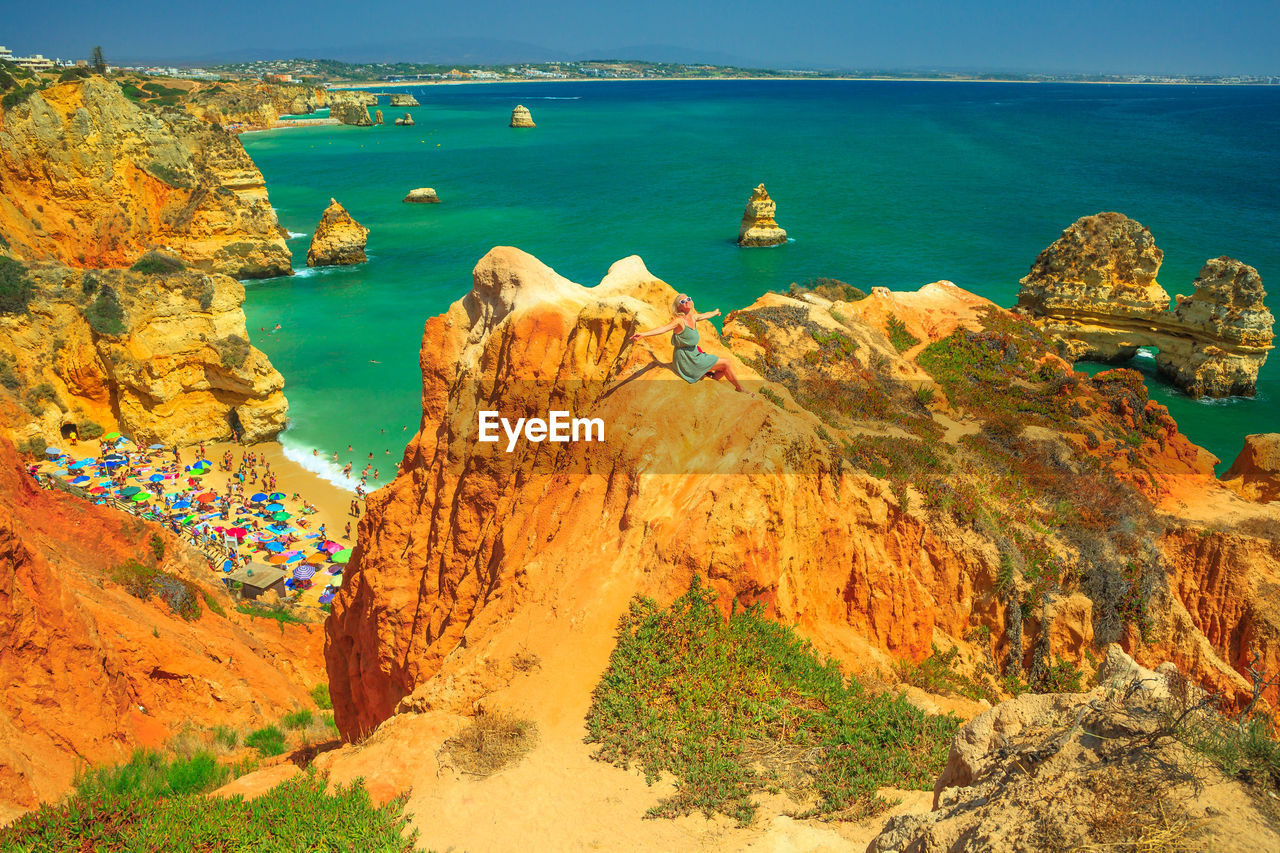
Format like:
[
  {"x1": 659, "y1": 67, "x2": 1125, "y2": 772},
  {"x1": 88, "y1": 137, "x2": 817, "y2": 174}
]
[{"x1": 38, "y1": 441, "x2": 364, "y2": 607}]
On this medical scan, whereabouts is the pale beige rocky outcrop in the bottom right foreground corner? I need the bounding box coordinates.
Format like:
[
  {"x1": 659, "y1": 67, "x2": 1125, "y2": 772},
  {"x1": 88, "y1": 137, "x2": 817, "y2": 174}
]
[{"x1": 867, "y1": 646, "x2": 1280, "y2": 853}]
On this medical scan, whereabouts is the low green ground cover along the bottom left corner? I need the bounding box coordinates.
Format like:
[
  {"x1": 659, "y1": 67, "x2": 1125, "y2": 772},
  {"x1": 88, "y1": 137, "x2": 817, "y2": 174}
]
[{"x1": 0, "y1": 772, "x2": 417, "y2": 853}]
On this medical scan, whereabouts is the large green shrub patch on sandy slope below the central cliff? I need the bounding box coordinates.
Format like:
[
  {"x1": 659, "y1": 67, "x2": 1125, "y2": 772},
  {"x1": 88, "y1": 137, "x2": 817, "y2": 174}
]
[{"x1": 586, "y1": 578, "x2": 957, "y2": 824}]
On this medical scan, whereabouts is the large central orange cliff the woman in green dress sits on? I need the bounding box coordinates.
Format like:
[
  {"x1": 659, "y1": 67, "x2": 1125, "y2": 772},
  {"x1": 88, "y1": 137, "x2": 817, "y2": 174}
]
[{"x1": 325, "y1": 242, "x2": 1280, "y2": 739}]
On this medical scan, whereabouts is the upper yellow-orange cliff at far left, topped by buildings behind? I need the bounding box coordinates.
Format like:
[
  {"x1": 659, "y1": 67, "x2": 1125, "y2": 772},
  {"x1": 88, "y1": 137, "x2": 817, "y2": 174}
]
[{"x1": 0, "y1": 77, "x2": 292, "y2": 278}]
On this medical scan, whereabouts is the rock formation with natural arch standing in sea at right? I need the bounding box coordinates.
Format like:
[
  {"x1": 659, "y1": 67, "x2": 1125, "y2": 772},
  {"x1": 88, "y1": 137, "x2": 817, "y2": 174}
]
[{"x1": 1018, "y1": 213, "x2": 1274, "y2": 397}]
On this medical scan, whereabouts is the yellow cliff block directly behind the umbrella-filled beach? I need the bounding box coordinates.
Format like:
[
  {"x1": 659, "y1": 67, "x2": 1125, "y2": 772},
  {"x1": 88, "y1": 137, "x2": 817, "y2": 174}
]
[{"x1": 0, "y1": 265, "x2": 288, "y2": 446}]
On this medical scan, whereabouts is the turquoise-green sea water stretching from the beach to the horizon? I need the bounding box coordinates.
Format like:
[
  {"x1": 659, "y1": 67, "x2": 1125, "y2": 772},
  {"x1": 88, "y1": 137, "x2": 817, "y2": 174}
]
[{"x1": 242, "y1": 81, "x2": 1280, "y2": 482}]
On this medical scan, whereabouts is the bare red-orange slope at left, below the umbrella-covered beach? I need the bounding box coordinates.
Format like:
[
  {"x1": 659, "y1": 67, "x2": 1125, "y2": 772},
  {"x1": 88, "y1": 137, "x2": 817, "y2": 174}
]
[{"x1": 0, "y1": 425, "x2": 324, "y2": 822}]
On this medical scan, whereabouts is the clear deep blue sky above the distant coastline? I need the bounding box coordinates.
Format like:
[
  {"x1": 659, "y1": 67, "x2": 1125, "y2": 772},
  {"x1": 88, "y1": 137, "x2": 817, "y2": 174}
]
[{"x1": 0, "y1": 0, "x2": 1280, "y2": 74}]
